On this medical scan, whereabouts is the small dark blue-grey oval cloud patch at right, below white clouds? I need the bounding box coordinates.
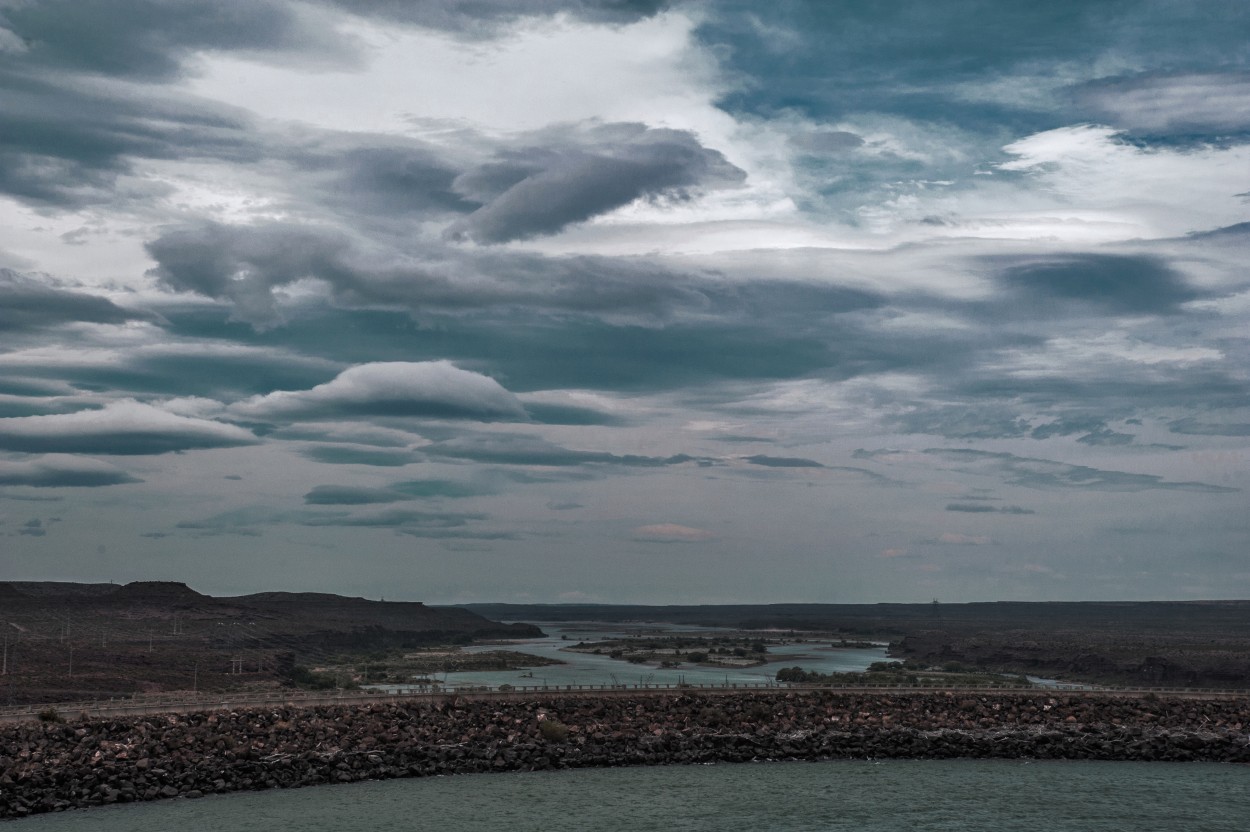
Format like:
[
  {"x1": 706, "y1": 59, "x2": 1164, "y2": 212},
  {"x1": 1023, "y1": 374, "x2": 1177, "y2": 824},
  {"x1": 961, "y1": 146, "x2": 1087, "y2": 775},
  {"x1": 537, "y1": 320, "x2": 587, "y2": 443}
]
[{"x1": 998, "y1": 252, "x2": 1201, "y2": 315}]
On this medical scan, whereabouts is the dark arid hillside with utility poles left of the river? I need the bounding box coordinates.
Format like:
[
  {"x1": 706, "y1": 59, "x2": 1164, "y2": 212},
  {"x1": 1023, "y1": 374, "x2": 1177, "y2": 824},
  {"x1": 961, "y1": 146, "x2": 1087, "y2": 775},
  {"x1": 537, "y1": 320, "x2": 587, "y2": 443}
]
[{"x1": 0, "y1": 581, "x2": 539, "y2": 705}]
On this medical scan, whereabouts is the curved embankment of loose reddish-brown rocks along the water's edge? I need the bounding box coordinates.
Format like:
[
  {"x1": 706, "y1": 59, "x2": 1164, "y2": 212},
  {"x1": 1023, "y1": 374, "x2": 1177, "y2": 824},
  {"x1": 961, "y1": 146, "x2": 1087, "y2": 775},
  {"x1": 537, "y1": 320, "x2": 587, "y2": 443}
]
[{"x1": 0, "y1": 691, "x2": 1250, "y2": 818}]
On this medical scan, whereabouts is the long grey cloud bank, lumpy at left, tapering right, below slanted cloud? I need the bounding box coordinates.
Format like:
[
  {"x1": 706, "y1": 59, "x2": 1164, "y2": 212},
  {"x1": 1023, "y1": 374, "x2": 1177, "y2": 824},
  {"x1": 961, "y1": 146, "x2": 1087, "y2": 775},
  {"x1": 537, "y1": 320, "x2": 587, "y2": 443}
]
[{"x1": 148, "y1": 222, "x2": 706, "y2": 324}]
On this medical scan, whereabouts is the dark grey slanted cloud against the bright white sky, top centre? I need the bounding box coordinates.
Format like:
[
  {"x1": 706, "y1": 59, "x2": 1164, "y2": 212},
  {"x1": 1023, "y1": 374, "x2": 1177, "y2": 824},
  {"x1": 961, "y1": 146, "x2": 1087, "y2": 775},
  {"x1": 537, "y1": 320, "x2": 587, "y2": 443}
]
[{"x1": 448, "y1": 124, "x2": 746, "y2": 242}]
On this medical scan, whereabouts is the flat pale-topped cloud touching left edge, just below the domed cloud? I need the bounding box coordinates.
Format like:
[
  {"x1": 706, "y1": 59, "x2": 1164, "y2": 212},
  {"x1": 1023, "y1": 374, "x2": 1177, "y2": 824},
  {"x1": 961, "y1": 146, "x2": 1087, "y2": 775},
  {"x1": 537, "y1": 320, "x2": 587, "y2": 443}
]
[{"x1": 0, "y1": 400, "x2": 260, "y2": 455}]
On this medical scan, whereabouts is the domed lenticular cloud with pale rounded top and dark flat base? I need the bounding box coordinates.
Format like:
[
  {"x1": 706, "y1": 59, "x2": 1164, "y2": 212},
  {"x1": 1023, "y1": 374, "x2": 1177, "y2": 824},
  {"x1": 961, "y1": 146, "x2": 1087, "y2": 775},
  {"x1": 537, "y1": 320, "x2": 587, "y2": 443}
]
[{"x1": 230, "y1": 361, "x2": 526, "y2": 421}]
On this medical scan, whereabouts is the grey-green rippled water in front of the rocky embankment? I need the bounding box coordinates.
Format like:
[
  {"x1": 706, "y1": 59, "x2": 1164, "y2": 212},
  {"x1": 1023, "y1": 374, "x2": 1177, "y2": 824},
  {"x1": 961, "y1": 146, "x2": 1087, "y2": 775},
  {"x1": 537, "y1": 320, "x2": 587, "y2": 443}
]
[{"x1": 10, "y1": 761, "x2": 1250, "y2": 832}]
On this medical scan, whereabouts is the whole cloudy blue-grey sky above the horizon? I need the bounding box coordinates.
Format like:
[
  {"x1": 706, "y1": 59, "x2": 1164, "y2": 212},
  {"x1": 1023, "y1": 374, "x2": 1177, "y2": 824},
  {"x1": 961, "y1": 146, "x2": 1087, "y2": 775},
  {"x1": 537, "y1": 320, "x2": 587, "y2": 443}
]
[{"x1": 0, "y1": 0, "x2": 1250, "y2": 603}]
